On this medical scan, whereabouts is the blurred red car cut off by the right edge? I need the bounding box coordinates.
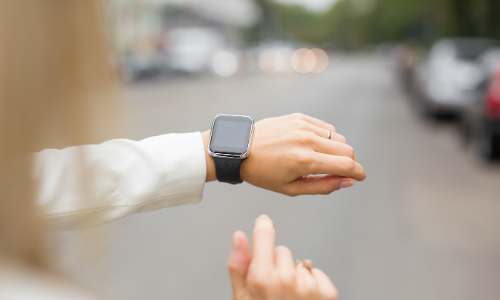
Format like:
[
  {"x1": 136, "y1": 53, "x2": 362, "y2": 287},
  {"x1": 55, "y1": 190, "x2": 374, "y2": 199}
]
[{"x1": 461, "y1": 49, "x2": 500, "y2": 160}]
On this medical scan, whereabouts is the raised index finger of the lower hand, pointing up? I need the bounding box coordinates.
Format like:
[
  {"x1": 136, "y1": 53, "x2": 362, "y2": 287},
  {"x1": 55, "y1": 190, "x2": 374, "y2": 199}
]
[{"x1": 252, "y1": 215, "x2": 276, "y2": 272}]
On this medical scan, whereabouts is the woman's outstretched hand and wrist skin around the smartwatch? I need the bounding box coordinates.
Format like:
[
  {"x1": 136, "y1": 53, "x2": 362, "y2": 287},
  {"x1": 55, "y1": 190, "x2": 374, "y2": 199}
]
[{"x1": 203, "y1": 114, "x2": 366, "y2": 196}]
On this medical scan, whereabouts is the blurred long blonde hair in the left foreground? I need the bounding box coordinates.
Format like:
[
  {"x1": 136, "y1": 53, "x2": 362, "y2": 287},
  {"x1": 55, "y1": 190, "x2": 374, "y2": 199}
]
[{"x1": 0, "y1": 0, "x2": 118, "y2": 267}]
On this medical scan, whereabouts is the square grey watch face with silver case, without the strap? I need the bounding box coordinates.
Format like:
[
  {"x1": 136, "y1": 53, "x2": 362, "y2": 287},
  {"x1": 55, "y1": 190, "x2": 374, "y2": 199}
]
[{"x1": 210, "y1": 115, "x2": 253, "y2": 156}]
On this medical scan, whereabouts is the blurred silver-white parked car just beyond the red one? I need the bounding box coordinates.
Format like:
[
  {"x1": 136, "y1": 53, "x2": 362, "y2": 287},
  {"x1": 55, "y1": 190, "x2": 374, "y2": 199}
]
[{"x1": 415, "y1": 38, "x2": 498, "y2": 116}]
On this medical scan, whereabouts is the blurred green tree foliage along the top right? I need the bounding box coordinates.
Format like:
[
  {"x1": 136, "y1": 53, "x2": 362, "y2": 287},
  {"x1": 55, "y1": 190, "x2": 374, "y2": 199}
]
[{"x1": 259, "y1": 0, "x2": 500, "y2": 48}]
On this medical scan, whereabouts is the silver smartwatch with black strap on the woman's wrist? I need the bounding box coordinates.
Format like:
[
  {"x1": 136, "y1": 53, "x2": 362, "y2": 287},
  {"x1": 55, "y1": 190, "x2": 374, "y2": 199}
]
[{"x1": 208, "y1": 114, "x2": 253, "y2": 184}]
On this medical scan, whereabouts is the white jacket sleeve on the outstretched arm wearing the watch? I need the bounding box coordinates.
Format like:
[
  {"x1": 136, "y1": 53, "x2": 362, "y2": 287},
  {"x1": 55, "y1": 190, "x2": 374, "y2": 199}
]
[{"x1": 34, "y1": 132, "x2": 206, "y2": 230}]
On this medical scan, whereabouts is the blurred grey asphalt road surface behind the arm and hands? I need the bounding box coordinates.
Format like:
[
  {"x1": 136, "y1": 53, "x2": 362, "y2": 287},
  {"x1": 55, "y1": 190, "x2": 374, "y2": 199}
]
[{"x1": 62, "y1": 56, "x2": 500, "y2": 300}]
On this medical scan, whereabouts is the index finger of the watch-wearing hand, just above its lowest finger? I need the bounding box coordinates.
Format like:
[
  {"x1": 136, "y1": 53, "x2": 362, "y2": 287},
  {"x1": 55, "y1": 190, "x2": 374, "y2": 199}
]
[{"x1": 304, "y1": 152, "x2": 366, "y2": 181}]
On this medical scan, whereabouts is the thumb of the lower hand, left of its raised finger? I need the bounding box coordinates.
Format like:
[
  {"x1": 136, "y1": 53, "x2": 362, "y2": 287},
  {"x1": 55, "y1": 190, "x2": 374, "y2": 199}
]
[{"x1": 227, "y1": 231, "x2": 251, "y2": 299}]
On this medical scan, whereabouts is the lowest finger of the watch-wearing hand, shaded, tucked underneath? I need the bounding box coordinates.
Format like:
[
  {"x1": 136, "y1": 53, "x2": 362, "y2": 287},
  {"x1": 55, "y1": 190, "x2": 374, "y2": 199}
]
[{"x1": 288, "y1": 175, "x2": 355, "y2": 196}]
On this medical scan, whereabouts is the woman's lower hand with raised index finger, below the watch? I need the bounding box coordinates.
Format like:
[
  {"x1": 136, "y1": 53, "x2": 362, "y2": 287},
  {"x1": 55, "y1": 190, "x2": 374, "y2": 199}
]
[{"x1": 227, "y1": 215, "x2": 338, "y2": 300}]
